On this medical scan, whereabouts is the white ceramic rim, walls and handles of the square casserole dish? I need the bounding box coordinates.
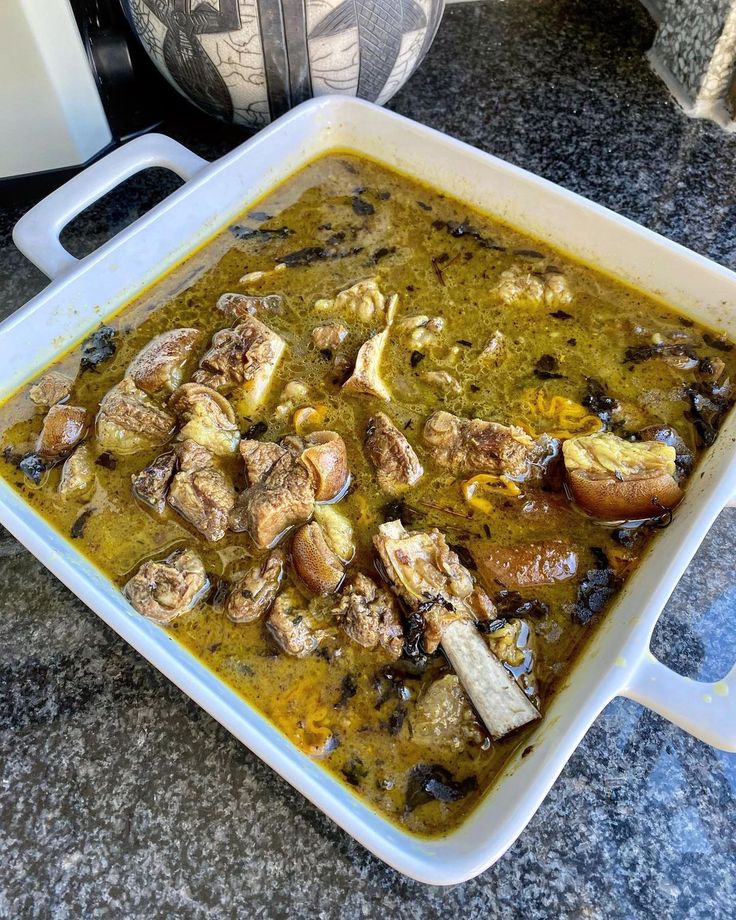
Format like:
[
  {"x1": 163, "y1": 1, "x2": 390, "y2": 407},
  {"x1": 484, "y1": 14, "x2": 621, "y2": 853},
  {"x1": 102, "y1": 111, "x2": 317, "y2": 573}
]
[{"x1": 5, "y1": 97, "x2": 736, "y2": 885}]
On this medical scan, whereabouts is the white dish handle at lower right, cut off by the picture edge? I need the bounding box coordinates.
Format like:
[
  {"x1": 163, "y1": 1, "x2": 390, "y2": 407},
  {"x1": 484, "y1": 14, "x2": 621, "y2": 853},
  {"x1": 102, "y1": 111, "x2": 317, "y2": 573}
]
[{"x1": 621, "y1": 651, "x2": 736, "y2": 751}]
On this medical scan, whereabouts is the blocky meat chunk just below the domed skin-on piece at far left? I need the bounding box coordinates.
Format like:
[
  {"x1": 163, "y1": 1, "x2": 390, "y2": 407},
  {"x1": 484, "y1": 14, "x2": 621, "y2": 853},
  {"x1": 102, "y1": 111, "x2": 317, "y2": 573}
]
[{"x1": 97, "y1": 377, "x2": 175, "y2": 454}]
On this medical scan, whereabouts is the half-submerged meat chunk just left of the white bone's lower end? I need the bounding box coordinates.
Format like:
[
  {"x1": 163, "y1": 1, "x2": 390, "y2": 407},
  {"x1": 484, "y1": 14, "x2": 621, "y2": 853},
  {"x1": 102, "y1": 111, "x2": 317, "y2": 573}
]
[{"x1": 409, "y1": 674, "x2": 483, "y2": 751}]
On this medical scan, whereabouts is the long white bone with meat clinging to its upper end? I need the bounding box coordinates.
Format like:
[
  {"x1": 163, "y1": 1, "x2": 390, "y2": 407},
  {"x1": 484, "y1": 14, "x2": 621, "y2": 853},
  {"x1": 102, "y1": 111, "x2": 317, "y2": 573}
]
[{"x1": 373, "y1": 521, "x2": 539, "y2": 740}]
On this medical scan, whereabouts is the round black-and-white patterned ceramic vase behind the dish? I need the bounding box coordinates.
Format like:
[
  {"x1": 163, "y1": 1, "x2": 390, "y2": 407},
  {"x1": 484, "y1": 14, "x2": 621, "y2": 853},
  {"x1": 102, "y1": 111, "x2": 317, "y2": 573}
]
[{"x1": 122, "y1": 0, "x2": 444, "y2": 128}]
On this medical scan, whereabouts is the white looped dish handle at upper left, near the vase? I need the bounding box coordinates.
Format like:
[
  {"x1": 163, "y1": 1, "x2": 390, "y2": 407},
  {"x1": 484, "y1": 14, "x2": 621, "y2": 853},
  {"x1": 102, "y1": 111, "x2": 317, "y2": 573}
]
[{"x1": 13, "y1": 134, "x2": 209, "y2": 280}]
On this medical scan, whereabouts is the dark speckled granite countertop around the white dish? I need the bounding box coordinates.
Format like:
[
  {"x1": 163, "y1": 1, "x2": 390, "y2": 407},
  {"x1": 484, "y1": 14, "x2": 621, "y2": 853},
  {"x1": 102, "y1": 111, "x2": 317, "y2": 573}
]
[{"x1": 0, "y1": 0, "x2": 736, "y2": 920}]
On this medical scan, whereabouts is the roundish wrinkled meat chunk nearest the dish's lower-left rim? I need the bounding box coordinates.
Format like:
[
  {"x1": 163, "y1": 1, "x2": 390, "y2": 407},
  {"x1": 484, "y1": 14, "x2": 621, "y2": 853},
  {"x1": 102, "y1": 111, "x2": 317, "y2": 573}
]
[{"x1": 123, "y1": 549, "x2": 209, "y2": 624}]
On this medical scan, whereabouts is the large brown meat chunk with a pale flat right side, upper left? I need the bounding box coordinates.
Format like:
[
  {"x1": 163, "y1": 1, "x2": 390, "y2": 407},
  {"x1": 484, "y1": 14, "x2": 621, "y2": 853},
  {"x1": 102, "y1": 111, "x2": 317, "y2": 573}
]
[{"x1": 192, "y1": 316, "x2": 286, "y2": 415}]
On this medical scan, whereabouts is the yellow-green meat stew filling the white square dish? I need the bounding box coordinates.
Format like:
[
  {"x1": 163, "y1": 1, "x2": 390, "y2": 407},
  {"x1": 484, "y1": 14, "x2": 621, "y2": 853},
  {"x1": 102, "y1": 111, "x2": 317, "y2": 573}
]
[{"x1": 0, "y1": 154, "x2": 736, "y2": 834}]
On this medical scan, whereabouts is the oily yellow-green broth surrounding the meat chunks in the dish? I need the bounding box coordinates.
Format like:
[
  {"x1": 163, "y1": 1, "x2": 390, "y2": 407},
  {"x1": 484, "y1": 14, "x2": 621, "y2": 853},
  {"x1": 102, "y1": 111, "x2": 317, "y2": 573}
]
[{"x1": 0, "y1": 155, "x2": 735, "y2": 834}]
